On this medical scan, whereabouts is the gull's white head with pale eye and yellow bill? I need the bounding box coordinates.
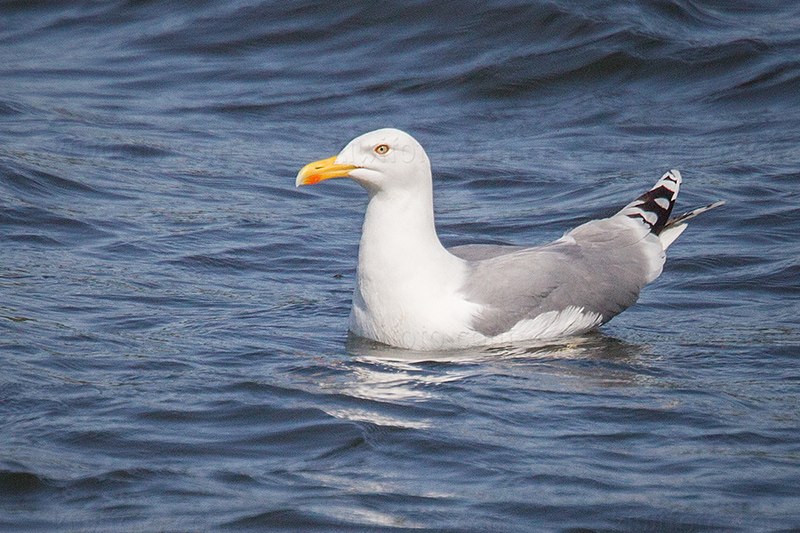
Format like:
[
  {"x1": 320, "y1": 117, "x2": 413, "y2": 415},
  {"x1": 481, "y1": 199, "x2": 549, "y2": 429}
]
[{"x1": 295, "y1": 128, "x2": 431, "y2": 196}]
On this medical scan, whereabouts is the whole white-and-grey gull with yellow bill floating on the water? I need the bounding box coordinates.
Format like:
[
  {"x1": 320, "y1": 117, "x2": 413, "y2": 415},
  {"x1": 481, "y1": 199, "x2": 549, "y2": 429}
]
[{"x1": 297, "y1": 129, "x2": 716, "y2": 350}]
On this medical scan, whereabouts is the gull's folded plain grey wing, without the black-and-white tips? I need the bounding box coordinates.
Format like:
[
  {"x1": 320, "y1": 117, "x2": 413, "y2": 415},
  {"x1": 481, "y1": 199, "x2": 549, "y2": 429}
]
[{"x1": 450, "y1": 217, "x2": 664, "y2": 336}]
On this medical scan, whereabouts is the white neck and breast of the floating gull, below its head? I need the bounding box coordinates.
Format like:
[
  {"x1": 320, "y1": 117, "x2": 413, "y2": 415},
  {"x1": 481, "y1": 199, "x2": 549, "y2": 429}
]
[{"x1": 350, "y1": 187, "x2": 470, "y2": 347}]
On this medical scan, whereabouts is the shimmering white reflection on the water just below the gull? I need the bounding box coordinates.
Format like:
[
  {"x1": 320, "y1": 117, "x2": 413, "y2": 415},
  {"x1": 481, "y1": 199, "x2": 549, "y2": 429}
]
[{"x1": 328, "y1": 333, "x2": 653, "y2": 427}]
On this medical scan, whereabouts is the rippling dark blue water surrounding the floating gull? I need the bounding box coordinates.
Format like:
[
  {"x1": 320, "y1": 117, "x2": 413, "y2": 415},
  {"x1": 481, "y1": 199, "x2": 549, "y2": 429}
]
[{"x1": 0, "y1": 0, "x2": 800, "y2": 532}]
